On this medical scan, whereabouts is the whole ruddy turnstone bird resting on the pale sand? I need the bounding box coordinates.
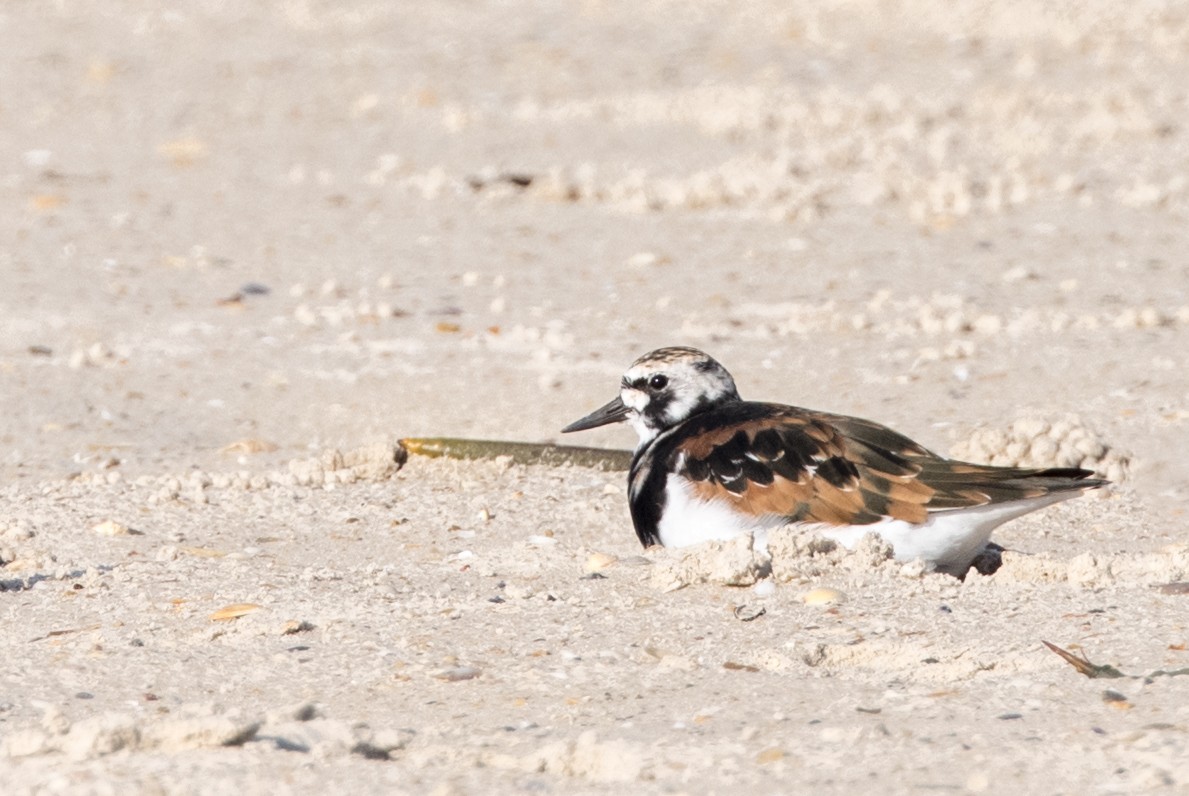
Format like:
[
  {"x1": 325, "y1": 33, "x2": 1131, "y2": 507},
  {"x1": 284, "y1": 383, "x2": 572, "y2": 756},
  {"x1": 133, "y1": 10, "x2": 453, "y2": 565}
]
[{"x1": 562, "y1": 347, "x2": 1108, "y2": 577}]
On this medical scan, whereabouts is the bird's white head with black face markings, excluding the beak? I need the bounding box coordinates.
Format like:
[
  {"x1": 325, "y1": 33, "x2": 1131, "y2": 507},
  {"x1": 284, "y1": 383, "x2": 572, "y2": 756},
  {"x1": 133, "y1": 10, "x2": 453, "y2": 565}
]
[{"x1": 619, "y1": 347, "x2": 740, "y2": 446}]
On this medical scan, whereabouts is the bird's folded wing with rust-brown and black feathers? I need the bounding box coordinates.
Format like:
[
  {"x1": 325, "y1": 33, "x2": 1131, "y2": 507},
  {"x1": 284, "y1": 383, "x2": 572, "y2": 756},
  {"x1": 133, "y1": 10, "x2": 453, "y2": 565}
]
[{"x1": 669, "y1": 405, "x2": 1106, "y2": 525}]
